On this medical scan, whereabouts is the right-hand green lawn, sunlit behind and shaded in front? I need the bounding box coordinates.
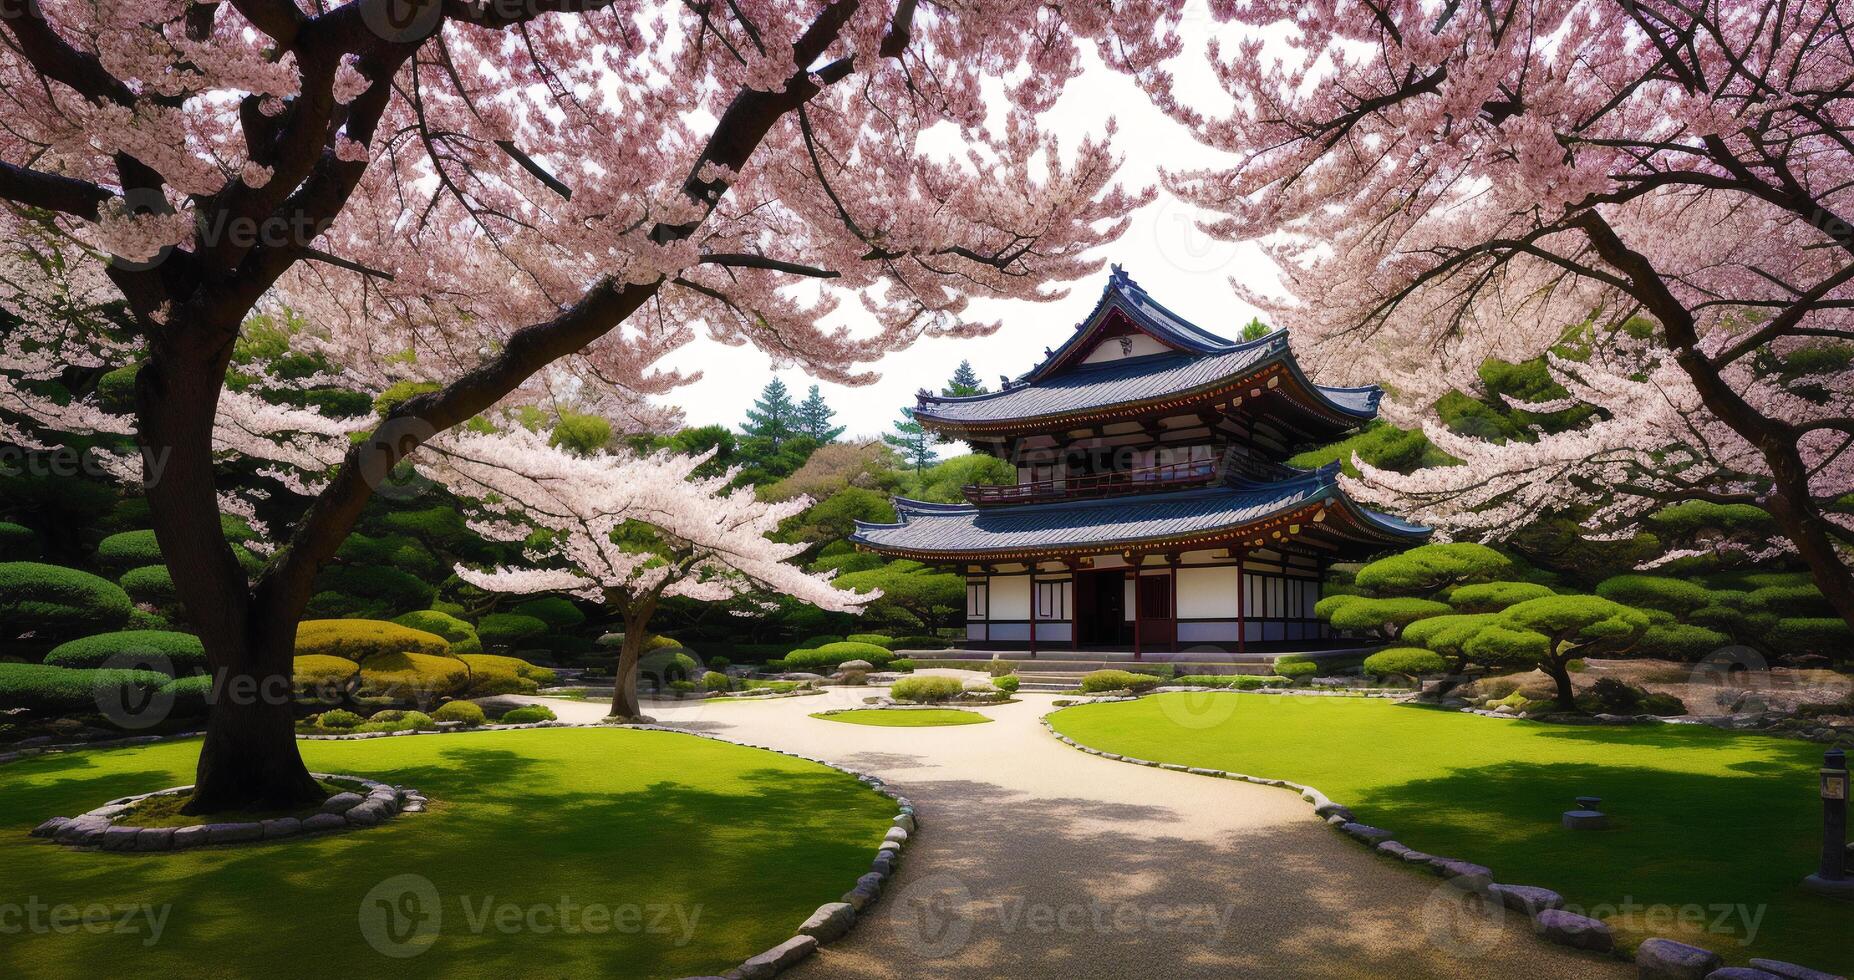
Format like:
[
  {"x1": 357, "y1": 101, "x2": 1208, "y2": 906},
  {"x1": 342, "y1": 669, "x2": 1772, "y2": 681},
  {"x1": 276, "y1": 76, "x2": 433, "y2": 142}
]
[{"x1": 1051, "y1": 693, "x2": 1854, "y2": 973}]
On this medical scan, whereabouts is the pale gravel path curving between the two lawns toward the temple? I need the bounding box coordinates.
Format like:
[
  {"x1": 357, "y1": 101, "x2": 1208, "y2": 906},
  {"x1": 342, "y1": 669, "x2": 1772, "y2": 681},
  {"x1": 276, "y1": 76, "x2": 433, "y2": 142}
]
[{"x1": 530, "y1": 689, "x2": 1633, "y2": 980}]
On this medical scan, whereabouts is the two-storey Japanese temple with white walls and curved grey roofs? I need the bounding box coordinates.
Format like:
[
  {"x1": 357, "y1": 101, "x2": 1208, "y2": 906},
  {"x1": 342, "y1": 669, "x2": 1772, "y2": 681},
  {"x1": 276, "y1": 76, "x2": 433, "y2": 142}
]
[{"x1": 851, "y1": 265, "x2": 1429, "y2": 654}]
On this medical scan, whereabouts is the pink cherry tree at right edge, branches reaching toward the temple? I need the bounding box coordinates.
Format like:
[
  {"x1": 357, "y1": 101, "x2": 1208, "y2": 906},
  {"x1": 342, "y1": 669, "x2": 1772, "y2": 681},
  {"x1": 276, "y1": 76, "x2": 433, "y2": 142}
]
[{"x1": 1166, "y1": 0, "x2": 1854, "y2": 624}]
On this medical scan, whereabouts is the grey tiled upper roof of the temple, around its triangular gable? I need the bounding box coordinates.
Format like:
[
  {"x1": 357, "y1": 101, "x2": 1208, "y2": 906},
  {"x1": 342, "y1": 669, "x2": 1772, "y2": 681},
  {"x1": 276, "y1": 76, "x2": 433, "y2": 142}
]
[{"x1": 914, "y1": 265, "x2": 1383, "y2": 428}]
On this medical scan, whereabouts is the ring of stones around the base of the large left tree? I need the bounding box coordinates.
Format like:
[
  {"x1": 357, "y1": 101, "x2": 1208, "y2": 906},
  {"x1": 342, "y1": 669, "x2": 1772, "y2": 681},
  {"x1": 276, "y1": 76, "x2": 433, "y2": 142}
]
[{"x1": 32, "y1": 773, "x2": 426, "y2": 854}]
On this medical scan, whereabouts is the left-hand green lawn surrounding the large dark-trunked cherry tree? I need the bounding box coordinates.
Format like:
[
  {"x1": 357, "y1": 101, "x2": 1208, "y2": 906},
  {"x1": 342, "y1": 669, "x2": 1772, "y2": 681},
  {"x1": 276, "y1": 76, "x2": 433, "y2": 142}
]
[{"x1": 0, "y1": 728, "x2": 894, "y2": 980}]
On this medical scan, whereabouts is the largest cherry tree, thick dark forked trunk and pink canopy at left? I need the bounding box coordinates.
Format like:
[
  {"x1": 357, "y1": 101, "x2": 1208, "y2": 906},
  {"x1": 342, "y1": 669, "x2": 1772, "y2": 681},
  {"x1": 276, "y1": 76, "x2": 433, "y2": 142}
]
[{"x1": 0, "y1": 0, "x2": 1177, "y2": 811}]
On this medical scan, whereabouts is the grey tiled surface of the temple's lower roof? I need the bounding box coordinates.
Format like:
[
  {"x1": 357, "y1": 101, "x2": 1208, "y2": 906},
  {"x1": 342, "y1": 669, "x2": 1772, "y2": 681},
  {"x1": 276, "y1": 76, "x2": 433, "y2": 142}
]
[{"x1": 849, "y1": 463, "x2": 1429, "y2": 558}]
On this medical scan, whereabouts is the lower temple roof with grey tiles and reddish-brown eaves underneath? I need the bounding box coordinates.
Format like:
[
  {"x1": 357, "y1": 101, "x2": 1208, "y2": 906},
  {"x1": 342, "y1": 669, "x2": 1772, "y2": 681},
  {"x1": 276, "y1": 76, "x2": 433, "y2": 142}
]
[{"x1": 849, "y1": 465, "x2": 1429, "y2": 561}]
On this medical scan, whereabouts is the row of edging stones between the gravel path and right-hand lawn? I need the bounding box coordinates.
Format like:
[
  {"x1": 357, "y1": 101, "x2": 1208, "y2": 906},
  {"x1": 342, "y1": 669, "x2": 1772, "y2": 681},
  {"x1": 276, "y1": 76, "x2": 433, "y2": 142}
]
[{"x1": 1038, "y1": 711, "x2": 1841, "y2": 980}]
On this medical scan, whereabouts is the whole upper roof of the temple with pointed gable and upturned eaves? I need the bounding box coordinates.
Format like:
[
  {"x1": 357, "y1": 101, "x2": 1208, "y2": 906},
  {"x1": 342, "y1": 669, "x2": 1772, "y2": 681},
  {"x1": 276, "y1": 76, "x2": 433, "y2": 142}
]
[{"x1": 914, "y1": 265, "x2": 1383, "y2": 433}]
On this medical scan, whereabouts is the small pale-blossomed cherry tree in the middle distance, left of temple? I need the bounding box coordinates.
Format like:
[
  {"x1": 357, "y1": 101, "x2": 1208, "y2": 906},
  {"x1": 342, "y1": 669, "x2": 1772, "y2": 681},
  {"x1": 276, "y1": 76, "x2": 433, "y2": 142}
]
[{"x1": 417, "y1": 428, "x2": 881, "y2": 719}]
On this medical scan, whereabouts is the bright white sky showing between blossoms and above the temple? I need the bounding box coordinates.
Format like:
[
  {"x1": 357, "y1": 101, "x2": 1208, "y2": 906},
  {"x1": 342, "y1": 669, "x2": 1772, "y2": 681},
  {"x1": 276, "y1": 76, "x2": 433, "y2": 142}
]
[{"x1": 664, "y1": 0, "x2": 1283, "y2": 437}]
